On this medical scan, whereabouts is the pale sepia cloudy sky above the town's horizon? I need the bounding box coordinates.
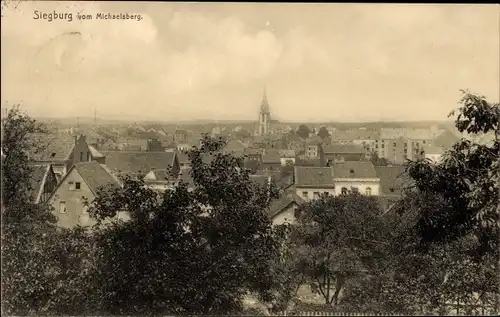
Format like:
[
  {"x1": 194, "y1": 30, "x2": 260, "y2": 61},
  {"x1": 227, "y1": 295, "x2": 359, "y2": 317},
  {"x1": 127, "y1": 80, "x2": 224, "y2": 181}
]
[{"x1": 0, "y1": 1, "x2": 500, "y2": 122}]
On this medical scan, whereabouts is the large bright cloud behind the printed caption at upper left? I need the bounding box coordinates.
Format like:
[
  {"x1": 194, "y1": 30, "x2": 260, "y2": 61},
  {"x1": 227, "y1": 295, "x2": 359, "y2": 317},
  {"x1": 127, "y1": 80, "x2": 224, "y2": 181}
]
[{"x1": 2, "y1": 2, "x2": 326, "y2": 99}]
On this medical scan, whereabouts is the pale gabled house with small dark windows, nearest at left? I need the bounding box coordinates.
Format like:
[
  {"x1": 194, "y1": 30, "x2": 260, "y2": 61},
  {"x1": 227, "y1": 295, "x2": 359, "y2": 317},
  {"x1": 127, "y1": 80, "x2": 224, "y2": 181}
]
[{"x1": 49, "y1": 161, "x2": 121, "y2": 228}]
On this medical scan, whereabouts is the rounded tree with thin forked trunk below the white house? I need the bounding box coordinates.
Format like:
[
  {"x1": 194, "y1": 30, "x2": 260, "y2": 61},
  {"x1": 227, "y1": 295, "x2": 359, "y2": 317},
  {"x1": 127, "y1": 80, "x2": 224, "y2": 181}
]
[{"x1": 294, "y1": 193, "x2": 386, "y2": 305}]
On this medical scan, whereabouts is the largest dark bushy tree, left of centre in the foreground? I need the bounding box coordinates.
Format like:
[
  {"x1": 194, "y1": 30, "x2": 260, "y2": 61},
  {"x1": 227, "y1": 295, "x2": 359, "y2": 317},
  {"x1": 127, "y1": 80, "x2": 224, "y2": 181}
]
[{"x1": 89, "y1": 136, "x2": 286, "y2": 314}]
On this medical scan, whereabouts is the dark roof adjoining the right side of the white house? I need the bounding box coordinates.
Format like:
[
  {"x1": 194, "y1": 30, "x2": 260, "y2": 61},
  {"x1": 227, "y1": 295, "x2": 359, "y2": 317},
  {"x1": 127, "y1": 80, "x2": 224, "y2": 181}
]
[{"x1": 375, "y1": 166, "x2": 412, "y2": 196}]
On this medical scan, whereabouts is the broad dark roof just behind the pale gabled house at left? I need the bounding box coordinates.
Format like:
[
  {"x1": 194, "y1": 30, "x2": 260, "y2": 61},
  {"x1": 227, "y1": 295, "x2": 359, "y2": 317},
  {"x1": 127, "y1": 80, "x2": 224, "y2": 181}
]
[{"x1": 28, "y1": 133, "x2": 75, "y2": 161}]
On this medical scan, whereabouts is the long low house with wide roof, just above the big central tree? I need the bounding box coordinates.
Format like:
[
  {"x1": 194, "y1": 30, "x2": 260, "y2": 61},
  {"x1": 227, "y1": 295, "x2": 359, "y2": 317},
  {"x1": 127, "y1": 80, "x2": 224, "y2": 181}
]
[{"x1": 99, "y1": 150, "x2": 180, "y2": 177}]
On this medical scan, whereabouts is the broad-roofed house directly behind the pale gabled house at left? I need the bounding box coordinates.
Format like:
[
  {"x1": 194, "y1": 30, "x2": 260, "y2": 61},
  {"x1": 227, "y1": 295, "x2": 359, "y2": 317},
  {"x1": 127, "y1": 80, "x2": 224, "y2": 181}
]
[{"x1": 28, "y1": 133, "x2": 104, "y2": 180}]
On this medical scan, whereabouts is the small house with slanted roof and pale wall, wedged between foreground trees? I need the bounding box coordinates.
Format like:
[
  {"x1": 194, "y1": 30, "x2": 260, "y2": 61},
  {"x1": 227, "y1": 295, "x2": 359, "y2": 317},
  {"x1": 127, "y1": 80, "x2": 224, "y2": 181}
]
[{"x1": 267, "y1": 192, "x2": 304, "y2": 226}]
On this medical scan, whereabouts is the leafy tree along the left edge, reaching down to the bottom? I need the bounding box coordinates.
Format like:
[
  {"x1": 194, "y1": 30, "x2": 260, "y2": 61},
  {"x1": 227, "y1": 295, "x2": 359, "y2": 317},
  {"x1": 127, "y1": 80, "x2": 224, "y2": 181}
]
[{"x1": 1, "y1": 106, "x2": 93, "y2": 315}]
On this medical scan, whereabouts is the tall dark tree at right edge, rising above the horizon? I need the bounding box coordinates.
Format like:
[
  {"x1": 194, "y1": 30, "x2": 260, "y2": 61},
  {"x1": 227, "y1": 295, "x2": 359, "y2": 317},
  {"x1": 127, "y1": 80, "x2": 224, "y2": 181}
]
[{"x1": 386, "y1": 91, "x2": 500, "y2": 311}]
